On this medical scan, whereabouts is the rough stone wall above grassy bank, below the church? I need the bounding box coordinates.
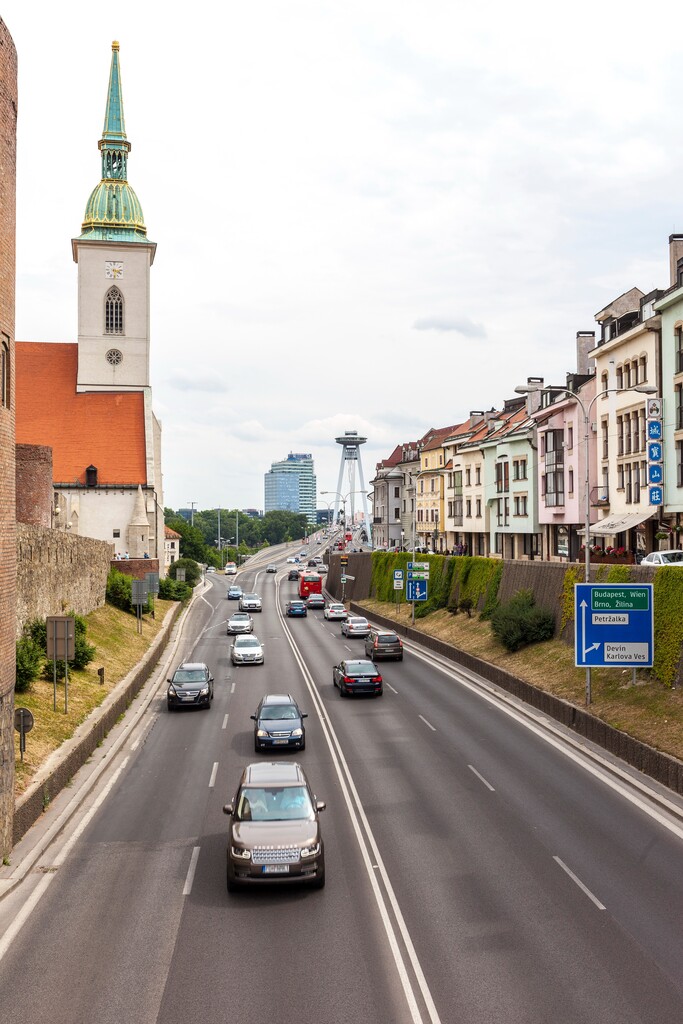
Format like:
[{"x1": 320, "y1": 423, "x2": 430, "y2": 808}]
[{"x1": 12, "y1": 523, "x2": 113, "y2": 634}]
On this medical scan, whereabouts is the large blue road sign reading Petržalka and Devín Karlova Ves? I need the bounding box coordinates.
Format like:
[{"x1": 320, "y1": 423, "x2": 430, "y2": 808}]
[{"x1": 574, "y1": 583, "x2": 654, "y2": 669}]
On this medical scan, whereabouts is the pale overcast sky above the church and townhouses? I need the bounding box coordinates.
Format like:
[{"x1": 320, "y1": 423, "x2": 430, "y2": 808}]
[{"x1": 1, "y1": 0, "x2": 683, "y2": 508}]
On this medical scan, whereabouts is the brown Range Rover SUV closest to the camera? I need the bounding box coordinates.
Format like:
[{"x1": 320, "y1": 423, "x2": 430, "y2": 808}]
[{"x1": 223, "y1": 761, "x2": 326, "y2": 892}]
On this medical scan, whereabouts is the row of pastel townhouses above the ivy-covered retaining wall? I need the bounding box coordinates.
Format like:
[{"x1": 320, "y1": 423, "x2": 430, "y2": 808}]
[{"x1": 372, "y1": 234, "x2": 683, "y2": 560}]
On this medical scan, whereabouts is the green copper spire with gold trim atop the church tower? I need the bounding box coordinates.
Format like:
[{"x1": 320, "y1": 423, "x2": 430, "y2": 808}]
[{"x1": 80, "y1": 42, "x2": 147, "y2": 242}]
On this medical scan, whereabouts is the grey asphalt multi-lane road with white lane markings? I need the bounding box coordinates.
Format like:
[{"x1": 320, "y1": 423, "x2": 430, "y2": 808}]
[{"x1": 0, "y1": 555, "x2": 683, "y2": 1024}]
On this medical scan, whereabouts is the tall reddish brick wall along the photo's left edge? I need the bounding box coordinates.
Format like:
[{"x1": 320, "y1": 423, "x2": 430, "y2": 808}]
[{"x1": 0, "y1": 18, "x2": 17, "y2": 857}]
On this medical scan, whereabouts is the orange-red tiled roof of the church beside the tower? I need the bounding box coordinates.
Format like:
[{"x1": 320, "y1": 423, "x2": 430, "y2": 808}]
[{"x1": 15, "y1": 341, "x2": 146, "y2": 484}]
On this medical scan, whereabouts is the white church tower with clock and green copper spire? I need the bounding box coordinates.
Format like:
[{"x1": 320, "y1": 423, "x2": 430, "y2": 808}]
[{"x1": 72, "y1": 42, "x2": 157, "y2": 391}]
